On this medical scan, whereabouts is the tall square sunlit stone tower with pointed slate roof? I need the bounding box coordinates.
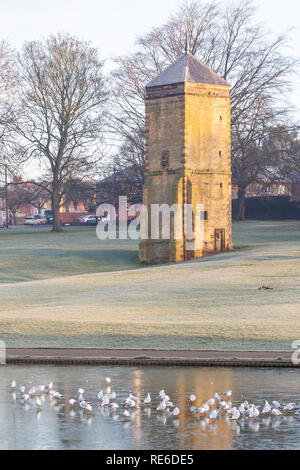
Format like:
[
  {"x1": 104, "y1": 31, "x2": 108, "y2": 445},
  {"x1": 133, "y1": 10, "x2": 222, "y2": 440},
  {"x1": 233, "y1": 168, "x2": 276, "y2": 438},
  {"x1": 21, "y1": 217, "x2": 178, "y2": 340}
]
[{"x1": 140, "y1": 48, "x2": 232, "y2": 263}]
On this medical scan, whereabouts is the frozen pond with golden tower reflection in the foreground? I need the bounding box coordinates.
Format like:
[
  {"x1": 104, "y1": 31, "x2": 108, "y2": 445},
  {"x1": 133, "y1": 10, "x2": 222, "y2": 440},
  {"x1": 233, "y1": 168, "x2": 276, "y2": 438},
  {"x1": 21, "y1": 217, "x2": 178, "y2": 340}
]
[{"x1": 0, "y1": 366, "x2": 300, "y2": 450}]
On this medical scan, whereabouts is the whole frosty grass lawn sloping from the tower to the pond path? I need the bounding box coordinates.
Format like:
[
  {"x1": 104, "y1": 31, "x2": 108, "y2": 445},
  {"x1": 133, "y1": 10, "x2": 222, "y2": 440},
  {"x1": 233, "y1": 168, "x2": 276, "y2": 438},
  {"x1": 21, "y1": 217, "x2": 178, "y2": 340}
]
[{"x1": 0, "y1": 221, "x2": 300, "y2": 351}]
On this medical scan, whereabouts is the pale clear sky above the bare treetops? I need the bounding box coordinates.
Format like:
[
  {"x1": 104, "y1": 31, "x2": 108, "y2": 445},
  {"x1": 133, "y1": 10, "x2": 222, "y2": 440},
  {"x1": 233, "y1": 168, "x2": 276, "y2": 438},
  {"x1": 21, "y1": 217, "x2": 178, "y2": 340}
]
[{"x1": 0, "y1": 0, "x2": 300, "y2": 174}]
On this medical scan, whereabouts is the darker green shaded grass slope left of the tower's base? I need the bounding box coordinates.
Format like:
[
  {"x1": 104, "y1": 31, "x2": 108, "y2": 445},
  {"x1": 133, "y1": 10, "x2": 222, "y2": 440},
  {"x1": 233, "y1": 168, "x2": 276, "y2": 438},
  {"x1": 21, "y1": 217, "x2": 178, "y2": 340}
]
[{"x1": 0, "y1": 227, "x2": 139, "y2": 284}]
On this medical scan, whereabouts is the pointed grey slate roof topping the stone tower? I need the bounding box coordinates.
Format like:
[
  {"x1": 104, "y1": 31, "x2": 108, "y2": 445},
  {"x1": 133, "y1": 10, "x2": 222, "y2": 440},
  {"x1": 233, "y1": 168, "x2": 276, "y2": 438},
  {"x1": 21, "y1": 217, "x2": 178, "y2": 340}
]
[{"x1": 146, "y1": 52, "x2": 230, "y2": 88}]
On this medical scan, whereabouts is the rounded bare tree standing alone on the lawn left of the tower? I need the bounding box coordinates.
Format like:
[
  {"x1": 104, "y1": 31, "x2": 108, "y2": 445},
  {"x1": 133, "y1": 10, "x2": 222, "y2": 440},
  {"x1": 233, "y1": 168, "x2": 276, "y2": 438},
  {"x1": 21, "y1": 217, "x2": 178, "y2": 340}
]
[{"x1": 16, "y1": 34, "x2": 107, "y2": 232}]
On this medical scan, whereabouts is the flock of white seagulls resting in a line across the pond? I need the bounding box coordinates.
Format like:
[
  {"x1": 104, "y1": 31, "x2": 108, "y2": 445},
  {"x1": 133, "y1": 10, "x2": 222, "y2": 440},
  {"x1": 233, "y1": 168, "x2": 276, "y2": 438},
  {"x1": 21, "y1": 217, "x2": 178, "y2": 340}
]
[{"x1": 9, "y1": 378, "x2": 300, "y2": 422}]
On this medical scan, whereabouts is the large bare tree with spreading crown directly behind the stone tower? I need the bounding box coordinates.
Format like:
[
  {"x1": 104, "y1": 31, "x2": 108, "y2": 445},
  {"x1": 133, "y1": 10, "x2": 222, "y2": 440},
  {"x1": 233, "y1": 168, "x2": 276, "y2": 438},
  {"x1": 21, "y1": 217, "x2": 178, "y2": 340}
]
[{"x1": 110, "y1": 0, "x2": 297, "y2": 218}]
